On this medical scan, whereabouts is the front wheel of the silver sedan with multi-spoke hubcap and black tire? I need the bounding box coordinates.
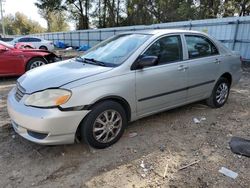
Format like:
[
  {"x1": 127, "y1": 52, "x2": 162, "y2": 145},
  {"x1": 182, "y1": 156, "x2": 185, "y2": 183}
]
[{"x1": 80, "y1": 100, "x2": 128, "y2": 149}]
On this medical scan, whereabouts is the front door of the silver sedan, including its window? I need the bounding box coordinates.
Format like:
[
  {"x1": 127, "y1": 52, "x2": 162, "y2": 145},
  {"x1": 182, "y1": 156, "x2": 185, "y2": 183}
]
[{"x1": 136, "y1": 35, "x2": 187, "y2": 117}]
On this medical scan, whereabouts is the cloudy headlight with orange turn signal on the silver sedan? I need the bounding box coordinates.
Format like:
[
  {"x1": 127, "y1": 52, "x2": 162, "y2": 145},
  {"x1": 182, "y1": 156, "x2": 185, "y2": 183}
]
[{"x1": 24, "y1": 89, "x2": 71, "y2": 108}]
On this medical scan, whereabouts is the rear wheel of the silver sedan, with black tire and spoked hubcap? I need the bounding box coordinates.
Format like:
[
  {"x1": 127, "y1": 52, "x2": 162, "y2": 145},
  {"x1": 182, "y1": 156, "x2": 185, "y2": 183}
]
[{"x1": 206, "y1": 77, "x2": 230, "y2": 108}]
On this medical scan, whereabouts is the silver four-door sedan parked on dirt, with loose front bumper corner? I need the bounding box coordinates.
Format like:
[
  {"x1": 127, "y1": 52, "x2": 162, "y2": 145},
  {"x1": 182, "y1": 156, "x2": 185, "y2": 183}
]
[{"x1": 8, "y1": 30, "x2": 241, "y2": 148}]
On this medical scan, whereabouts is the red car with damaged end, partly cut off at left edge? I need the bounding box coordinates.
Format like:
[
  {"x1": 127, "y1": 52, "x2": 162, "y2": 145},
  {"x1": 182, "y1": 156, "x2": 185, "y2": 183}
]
[{"x1": 0, "y1": 41, "x2": 60, "y2": 76}]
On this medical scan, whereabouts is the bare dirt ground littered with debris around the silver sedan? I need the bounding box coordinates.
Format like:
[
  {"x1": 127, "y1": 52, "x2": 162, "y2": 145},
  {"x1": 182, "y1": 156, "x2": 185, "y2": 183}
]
[{"x1": 0, "y1": 65, "x2": 250, "y2": 188}]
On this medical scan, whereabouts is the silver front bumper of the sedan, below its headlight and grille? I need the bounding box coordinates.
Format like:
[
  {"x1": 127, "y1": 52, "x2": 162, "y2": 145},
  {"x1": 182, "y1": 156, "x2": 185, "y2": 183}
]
[{"x1": 7, "y1": 88, "x2": 89, "y2": 145}]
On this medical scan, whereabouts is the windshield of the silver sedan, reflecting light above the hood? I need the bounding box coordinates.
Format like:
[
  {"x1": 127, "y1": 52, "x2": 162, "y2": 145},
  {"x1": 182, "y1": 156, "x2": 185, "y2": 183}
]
[{"x1": 82, "y1": 34, "x2": 151, "y2": 66}]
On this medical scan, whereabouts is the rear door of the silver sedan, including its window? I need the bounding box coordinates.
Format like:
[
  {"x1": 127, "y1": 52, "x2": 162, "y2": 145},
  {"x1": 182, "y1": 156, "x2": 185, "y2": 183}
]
[{"x1": 185, "y1": 34, "x2": 221, "y2": 101}]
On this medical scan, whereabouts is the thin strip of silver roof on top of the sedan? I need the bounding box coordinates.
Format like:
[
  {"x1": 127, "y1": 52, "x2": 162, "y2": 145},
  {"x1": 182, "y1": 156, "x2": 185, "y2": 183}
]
[{"x1": 122, "y1": 29, "x2": 202, "y2": 35}]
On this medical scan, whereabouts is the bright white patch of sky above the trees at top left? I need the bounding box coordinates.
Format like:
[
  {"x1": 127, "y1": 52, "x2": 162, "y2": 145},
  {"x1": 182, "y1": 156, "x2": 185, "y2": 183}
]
[{"x1": 3, "y1": 0, "x2": 47, "y2": 28}]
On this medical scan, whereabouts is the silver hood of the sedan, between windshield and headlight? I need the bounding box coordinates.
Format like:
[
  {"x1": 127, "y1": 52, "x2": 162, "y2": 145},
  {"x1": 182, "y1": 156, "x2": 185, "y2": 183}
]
[{"x1": 18, "y1": 59, "x2": 112, "y2": 93}]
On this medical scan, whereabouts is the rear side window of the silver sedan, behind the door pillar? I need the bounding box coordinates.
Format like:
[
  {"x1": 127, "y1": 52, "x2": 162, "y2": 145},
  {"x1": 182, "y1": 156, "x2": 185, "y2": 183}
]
[{"x1": 185, "y1": 35, "x2": 219, "y2": 59}]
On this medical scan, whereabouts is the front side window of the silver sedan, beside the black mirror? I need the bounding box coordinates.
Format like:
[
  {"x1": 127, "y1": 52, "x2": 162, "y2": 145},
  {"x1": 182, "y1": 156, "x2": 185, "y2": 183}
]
[{"x1": 143, "y1": 35, "x2": 182, "y2": 64}]
